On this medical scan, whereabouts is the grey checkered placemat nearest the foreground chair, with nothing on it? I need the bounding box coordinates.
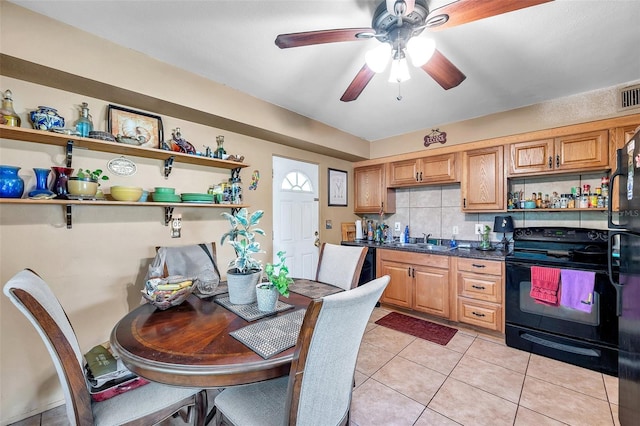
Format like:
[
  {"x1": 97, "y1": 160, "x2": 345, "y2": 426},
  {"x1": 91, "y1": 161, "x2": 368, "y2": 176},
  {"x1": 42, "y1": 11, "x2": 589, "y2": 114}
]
[{"x1": 229, "y1": 309, "x2": 306, "y2": 359}]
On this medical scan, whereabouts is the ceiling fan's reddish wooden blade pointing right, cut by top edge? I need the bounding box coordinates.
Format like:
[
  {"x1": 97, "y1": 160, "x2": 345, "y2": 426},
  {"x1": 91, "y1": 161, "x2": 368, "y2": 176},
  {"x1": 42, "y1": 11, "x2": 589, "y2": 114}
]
[{"x1": 427, "y1": 0, "x2": 553, "y2": 31}]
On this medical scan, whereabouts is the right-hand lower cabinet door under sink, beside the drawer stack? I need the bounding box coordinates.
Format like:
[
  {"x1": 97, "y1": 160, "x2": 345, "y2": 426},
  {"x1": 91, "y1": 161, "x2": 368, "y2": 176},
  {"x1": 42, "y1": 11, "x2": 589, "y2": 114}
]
[{"x1": 413, "y1": 266, "x2": 450, "y2": 318}]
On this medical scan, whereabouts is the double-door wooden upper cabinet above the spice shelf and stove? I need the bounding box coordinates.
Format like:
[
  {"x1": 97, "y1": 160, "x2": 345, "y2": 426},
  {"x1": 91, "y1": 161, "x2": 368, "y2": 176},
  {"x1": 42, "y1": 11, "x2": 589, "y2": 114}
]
[{"x1": 508, "y1": 130, "x2": 609, "y2": 176}]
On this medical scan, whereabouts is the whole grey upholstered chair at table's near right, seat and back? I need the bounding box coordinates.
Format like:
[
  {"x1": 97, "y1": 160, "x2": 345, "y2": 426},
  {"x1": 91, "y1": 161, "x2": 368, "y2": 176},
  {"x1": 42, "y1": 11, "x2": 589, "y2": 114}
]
[{"x1": 215, "y1": 275, "x2": 389, "y2": 426}]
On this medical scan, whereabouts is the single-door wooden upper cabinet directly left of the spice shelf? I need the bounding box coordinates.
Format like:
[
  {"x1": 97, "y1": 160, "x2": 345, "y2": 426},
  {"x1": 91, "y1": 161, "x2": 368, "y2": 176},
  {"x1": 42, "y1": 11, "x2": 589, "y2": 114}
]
[{"x1": 460, "y1": 146, "x2": 506, "y2": 212}]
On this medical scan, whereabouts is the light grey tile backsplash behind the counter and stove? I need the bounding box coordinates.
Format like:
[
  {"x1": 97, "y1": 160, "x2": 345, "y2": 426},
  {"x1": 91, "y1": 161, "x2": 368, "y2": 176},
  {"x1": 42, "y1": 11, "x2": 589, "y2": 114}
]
[{"x1": 363, "y1": 174, "x2": 607, "y2": 245}]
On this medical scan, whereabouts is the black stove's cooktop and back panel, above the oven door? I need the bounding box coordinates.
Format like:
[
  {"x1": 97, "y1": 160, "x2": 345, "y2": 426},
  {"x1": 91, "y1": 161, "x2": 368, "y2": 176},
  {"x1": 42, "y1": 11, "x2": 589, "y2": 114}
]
[{"x1": 507, "y1": 227, "x2": 608, "y2": 267}]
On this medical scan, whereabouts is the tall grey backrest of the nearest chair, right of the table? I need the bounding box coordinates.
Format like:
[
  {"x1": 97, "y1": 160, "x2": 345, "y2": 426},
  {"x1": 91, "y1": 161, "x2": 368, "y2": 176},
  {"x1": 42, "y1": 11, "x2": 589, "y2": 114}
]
[{"x1": 285, "y1": 275, "x2": 389, "y2": 425}]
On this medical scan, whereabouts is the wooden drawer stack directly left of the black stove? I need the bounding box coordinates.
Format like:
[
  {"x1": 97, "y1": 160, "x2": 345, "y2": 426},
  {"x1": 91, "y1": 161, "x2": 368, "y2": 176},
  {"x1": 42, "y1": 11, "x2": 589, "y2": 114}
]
[{"x1": 455, "y1": 257, "x2": 504, "y2": 332}]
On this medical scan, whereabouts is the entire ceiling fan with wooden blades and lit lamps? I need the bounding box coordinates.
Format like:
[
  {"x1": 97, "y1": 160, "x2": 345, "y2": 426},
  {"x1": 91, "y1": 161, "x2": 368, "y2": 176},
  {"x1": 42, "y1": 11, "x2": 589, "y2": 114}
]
[{"x1": 275, "y1": 0, "x2": 553, "y2": 102}]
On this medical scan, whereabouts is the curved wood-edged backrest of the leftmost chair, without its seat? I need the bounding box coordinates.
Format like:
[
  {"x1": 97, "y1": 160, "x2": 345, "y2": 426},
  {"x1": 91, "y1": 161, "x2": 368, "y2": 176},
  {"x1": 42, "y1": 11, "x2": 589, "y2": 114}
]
[{"x1": 3, "y1": 269, "x2": 93, "y2": 425}]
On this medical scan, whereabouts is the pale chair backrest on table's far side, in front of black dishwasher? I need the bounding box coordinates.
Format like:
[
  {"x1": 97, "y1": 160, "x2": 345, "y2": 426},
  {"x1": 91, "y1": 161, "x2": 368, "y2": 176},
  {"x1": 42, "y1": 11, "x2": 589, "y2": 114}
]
[{"x1": 316, "y1": 243, "x2": 367, "y2": 290}]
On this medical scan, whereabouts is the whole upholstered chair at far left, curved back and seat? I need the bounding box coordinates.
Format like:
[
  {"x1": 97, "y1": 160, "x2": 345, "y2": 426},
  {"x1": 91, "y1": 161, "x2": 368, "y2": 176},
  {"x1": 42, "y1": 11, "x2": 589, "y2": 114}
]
[{"x1": 4, "y1": 269, "x2": 207, "y2": 426}]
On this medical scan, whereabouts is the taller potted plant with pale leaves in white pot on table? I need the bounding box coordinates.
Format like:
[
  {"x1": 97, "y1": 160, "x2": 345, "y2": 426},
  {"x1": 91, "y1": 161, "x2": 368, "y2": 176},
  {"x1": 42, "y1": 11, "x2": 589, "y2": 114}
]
[{"x1": 220, "y1": 208, "x2": 265, "y2": 305}]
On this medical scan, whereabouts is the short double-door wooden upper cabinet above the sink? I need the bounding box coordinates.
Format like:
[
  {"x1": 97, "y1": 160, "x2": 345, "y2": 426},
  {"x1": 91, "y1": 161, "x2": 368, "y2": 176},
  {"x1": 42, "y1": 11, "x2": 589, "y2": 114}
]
[{"x1": 389, "y1": 153, "x2": 459, "y2": 187}]
